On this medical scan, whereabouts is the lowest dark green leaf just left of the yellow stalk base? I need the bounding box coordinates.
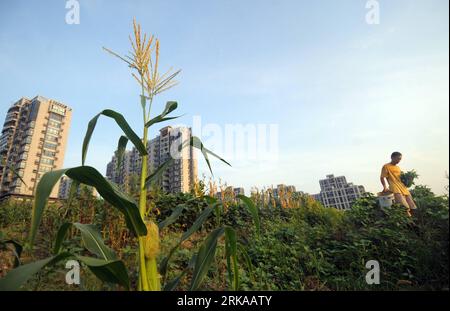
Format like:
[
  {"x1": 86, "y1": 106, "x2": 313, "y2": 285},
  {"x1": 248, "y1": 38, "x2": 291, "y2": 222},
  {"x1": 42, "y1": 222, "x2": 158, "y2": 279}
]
[{"x1": 75, "y1": 255, "x2": 130, "y2": 290}]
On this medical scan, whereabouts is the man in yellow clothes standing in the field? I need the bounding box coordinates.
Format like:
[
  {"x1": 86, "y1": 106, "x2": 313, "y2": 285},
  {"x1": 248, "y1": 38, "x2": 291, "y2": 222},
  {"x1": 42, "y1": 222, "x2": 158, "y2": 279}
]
[{"x1": 380, "y1": 152, "x2": 417, "y2": 216}]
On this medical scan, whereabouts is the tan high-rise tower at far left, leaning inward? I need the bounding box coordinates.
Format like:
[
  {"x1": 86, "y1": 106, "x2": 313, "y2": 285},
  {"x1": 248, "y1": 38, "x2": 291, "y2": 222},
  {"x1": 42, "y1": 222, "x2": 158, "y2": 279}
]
[{"x1": 0, "y1": 96, "x2": 72, "y2": 198}]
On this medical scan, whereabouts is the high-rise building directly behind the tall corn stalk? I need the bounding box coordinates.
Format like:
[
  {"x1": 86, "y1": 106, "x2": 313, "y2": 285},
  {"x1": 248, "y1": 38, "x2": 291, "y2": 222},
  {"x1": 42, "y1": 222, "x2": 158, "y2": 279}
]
[{"x1": 106, "y1": 126, "x2": 197, "y2": 193}]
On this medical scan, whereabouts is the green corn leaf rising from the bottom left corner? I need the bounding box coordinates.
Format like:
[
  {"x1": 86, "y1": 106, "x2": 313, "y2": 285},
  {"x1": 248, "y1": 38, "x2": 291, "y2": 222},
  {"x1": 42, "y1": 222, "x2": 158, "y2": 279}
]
[{"x1": 0, "y1": 253, "x2": 71, "y2": 291}]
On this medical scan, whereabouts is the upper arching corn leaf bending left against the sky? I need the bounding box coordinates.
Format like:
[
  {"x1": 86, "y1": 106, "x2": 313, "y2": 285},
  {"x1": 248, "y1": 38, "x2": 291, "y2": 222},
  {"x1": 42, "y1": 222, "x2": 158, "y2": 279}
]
[{"x1": 81, "y1": 109, "x2": 147, "y2": 165}]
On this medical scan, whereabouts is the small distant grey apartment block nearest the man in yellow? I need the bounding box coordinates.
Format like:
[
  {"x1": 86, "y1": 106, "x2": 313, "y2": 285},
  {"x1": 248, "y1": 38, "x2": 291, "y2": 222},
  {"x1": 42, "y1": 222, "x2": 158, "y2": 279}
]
[{"x1": 313, "y1": 175, "x2": 366, "y2": 209}]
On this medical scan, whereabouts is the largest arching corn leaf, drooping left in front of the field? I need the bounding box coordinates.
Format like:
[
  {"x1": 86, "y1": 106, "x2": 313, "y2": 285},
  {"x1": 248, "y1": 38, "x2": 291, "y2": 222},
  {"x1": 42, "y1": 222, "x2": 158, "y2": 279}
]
[{"x1": 29, "y1": 166, "x2": 147, "y2": 245}]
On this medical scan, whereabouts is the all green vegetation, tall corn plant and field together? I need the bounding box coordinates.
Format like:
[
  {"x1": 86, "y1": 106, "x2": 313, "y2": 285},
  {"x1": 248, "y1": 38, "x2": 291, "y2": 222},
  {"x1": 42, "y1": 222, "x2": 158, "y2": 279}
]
[{"x1": 0, "y1": 20, "x2": 449, "y2": 291}]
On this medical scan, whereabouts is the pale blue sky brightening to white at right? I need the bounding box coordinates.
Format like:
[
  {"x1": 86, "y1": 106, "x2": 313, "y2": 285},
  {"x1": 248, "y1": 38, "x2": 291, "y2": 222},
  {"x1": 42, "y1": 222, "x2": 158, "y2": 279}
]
[{"x1": 0, "y1": 0, "x2": 449, "y2": 194}]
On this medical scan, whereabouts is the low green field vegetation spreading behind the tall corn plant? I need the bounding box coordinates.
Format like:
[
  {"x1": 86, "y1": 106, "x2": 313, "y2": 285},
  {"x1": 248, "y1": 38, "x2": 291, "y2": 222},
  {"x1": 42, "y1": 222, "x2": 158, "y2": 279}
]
[{"x1": 0, "y1": 186, "x2": 449, "y2": 290}]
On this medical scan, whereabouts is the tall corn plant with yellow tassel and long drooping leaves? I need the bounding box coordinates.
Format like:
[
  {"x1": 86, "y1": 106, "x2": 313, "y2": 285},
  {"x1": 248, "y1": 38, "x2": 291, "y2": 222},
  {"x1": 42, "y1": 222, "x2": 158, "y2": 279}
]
[{"x1": 0, "y1": 22, "x2": 259, "y2": 291}]
